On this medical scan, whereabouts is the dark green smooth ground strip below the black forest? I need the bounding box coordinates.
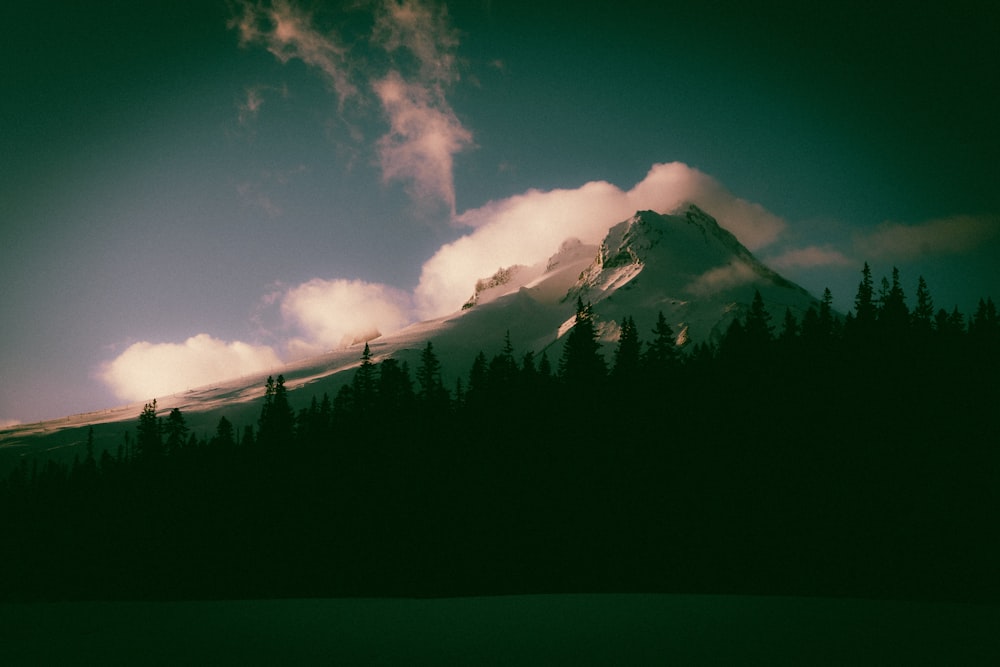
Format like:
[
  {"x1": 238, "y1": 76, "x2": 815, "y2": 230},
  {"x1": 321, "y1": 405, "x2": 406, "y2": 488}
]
[{"x1": 0, "y1": 595, "x2": 1000, "y2": 665}]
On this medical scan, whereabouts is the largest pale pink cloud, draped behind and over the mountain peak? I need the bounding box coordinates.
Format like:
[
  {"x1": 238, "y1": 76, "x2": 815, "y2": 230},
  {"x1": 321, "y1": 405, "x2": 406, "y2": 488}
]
[{"x1": 415, "y1": 162, "x2": 785, "y2": 317}]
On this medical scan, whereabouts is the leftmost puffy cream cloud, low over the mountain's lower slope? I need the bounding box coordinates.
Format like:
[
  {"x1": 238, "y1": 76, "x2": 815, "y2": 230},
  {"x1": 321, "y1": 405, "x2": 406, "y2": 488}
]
[{"x1": 99, "y1": 334, "x2": 281, "y2": 402}]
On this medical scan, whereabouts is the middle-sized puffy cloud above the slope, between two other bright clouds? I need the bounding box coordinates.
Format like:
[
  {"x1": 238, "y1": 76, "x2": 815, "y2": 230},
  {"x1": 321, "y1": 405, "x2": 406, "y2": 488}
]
[{"x1": 281, "y1": 278, "x2": 412, "y2": 356}]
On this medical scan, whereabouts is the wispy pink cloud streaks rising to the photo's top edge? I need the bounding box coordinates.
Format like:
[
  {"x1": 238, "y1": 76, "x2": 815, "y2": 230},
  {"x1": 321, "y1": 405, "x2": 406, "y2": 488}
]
[{"x1": 231, "y1": 0, "x2": 473, "y2": 211}]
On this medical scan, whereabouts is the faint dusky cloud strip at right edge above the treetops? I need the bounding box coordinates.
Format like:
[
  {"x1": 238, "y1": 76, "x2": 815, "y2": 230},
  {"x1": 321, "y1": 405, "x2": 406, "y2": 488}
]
[{"x1": 854, "y1": 215, "x2": 1000, "y2": 259}]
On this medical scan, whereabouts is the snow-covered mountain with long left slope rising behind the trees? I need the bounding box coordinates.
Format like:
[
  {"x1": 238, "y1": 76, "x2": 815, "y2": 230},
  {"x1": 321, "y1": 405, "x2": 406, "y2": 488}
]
[{"x1": 0, "y1": 204, "x2": 816, "y2": 467}]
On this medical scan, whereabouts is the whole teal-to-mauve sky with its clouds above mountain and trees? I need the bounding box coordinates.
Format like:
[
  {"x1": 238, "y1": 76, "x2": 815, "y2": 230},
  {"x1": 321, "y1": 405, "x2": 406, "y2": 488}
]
[{"x1": 0, "y1": 0, "x2": 1000, "y2": 424}]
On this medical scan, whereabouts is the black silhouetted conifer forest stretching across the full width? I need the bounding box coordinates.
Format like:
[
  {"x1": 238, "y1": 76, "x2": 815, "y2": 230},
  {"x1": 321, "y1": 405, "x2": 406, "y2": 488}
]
[{"x1": 0, "y1": 264, "x2": 1000, "y2": 602}]
